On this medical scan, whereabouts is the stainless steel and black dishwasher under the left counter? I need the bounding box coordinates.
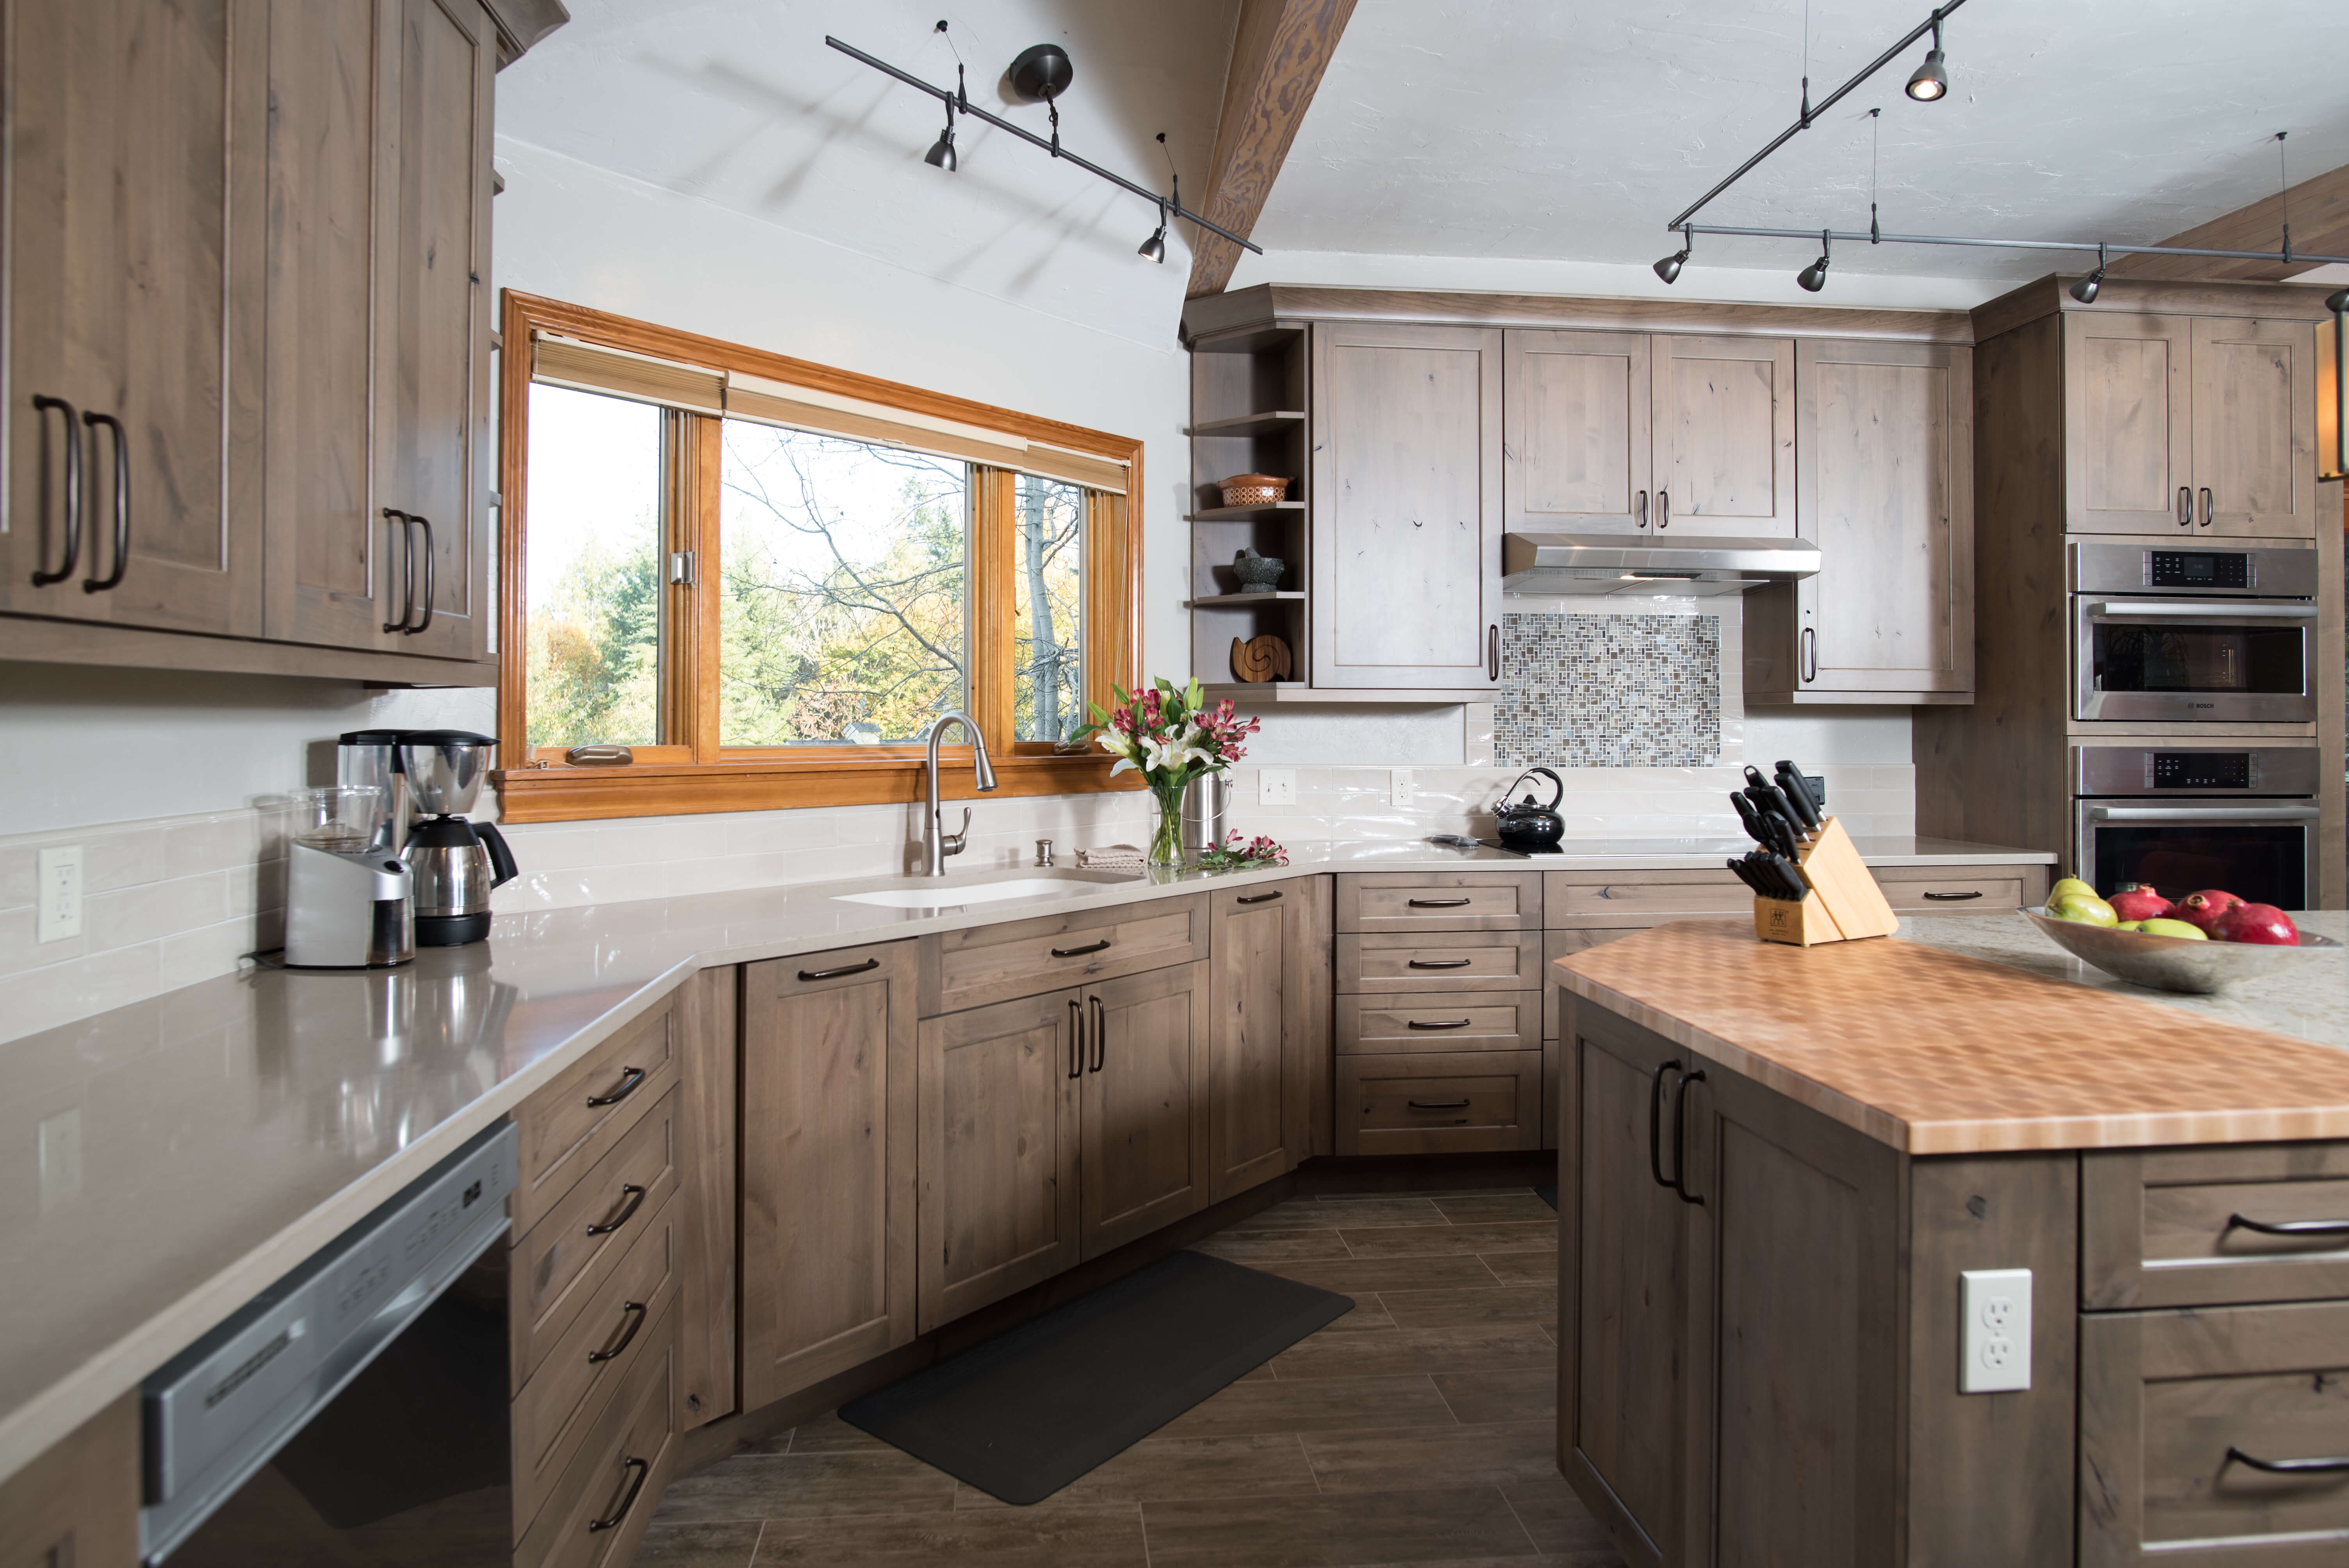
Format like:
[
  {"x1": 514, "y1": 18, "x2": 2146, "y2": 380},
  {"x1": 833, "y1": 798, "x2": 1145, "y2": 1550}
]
[{"x1": 139, "y1": 1127, "x2": 517, "y2": 1568}]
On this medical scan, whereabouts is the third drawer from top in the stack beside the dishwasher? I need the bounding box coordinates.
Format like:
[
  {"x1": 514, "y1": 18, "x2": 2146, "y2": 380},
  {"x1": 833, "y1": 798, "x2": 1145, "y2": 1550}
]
[{"x1": 515, "y1": 1202, "x2": 681, "y2": 1519}]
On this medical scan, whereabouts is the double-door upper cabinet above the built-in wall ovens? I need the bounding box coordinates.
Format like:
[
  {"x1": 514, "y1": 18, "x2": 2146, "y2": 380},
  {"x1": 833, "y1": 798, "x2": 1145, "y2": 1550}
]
[{"x1": 2062, "y1": 310, "x2": 2316, "y2": 538}]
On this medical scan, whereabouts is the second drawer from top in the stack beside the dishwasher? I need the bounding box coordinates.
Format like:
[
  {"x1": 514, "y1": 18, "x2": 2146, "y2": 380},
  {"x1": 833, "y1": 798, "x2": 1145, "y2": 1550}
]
[{"x1": 510, "y1": 1094, "x2": 679, "y2": 1392}]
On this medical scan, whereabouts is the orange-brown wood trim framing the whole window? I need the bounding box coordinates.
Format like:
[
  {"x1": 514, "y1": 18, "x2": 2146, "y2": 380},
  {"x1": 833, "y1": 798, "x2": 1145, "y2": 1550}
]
[{"x1": 491, "y1": 289, "x2": 1142, "y2": 821}]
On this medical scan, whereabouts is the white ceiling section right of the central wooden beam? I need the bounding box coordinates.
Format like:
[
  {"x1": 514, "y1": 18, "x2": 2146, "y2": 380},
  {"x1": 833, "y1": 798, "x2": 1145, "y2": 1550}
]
[{"x1": 1255, "y1": 0, "x2": 2349, "y2": 282}]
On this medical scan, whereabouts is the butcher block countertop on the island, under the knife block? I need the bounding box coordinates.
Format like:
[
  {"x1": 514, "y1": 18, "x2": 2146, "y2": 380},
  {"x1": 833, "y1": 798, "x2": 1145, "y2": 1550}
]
[{"x1": 1553, "y1": 913, "x2": 2349, "y2": 1155}]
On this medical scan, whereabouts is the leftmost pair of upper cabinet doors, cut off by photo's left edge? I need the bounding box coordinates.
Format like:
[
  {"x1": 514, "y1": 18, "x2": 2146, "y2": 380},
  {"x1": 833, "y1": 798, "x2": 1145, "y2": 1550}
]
[{"x1": 0, "y1": 0, "x2": 261, "y2": 636}]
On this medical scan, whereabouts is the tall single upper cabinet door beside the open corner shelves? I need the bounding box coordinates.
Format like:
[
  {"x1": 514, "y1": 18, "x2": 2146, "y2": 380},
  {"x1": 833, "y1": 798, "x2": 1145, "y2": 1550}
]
[{"x1": 1308, "y1": 326, "x2": 1501, "y2": 690}]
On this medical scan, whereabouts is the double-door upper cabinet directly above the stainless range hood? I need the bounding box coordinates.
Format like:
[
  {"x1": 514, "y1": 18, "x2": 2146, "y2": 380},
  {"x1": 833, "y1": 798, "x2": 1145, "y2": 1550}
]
[{"x1": 1503, "y1": 329, "x2": 1795, "y2": 538}]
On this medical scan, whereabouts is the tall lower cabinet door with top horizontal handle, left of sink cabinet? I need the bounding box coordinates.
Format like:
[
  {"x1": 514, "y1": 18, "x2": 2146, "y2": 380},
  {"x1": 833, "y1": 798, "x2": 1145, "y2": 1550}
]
[{"x1": 742, "y1": 941, "x2": 916, "y2": 1408}]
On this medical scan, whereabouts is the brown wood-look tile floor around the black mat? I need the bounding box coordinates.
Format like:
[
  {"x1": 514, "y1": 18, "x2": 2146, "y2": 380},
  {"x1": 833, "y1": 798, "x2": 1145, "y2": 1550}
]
[{"x1": 636, "y1": 1188, "x2": 1621, "y2": 1568}]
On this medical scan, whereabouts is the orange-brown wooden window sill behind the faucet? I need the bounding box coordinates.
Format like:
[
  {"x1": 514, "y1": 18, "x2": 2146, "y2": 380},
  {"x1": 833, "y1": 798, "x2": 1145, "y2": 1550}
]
[{"x1": 491, "y1": 751, "x2": 1142, "y2": 821}]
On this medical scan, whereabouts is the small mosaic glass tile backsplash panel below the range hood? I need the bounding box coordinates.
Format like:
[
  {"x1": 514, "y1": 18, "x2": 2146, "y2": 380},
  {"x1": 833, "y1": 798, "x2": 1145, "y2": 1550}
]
[{"x1": 1492, "y1": 615, "x2": 1722, "y2": 768}]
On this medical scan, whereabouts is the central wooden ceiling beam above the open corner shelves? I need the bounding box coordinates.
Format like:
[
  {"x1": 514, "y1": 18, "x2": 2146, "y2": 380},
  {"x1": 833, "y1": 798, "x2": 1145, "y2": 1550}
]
[{"x1": 1186, "y1": 0, "x2": 1353, "y2": 301}]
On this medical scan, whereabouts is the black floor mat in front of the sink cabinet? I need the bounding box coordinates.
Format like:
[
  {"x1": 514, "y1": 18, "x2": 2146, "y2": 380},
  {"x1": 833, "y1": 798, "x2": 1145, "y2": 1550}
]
[{"x1": 841, "y1": 1251, "x2": 1353, "y2": 1502}]
